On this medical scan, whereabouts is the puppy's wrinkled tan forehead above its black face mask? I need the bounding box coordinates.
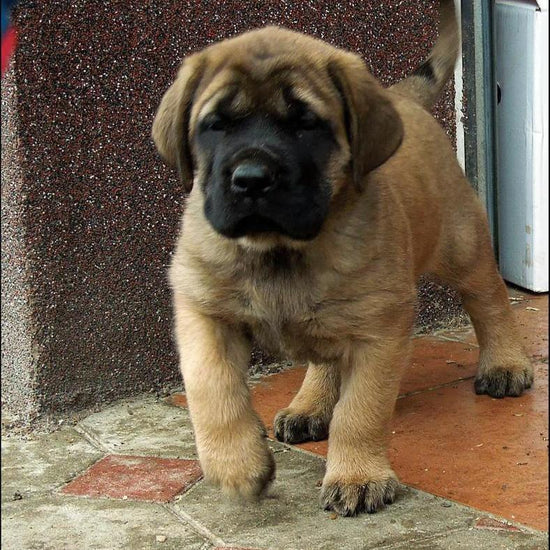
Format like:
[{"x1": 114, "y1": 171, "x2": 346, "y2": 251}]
[{"x1": 191, "y1": 41, "x2": 337, "y2": 125}]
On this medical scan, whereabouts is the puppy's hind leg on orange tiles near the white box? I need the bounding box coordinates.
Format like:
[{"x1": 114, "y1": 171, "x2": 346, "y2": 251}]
[{"x1": 437, "y1": 201, "x2": 533, "y2": 397}]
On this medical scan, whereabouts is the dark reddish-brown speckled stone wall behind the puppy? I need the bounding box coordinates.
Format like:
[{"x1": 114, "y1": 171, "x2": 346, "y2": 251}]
[{"x1": 2, "y1": 0, "x2": 464, "y2": 422}]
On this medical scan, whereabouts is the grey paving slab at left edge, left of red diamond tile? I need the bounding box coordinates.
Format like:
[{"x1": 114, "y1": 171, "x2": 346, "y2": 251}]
[{"x1": 2, "y1": 428, "x2": 103, "y2": 502}]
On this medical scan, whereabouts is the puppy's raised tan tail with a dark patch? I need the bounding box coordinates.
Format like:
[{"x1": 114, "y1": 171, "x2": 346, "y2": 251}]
[{"x1": 391, "y1": 0, "x2": 460, "y2": 109}]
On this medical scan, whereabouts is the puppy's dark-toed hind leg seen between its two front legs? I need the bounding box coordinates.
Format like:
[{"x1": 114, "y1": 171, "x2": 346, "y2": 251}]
[{"x1": 273, "y1": 363, "x2": 340, "y2": 443}]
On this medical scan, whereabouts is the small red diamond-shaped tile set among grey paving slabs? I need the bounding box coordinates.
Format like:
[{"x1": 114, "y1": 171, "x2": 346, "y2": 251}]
[{"x1": 61, "y1": 455, "x2": 202, "y2": 502}]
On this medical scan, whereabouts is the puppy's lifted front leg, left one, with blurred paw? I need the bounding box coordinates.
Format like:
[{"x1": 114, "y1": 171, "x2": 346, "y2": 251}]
[{"x1": 174, "y1": 295, "x2": 275, "y2": 498}]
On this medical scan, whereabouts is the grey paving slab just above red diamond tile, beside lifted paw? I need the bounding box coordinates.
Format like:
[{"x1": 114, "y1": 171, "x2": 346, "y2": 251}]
[{"x1": 77, "y1": 398, "x2": 197, "y2": 460}]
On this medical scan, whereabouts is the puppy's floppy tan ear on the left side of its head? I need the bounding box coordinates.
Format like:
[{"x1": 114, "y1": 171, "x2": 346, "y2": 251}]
[{"x1": 152, "y1": 55, "x2": 203, "y2": 191}]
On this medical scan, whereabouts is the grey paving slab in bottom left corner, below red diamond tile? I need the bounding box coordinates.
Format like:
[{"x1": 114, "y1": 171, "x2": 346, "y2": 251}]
[{"x1": 2, "y1": 496, "x2": 211, "y2": 550}]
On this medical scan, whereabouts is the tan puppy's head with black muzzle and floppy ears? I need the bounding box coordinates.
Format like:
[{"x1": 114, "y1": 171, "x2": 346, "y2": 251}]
[{"x1": 153, "y1": 27, "x2": 402, "y2": 247}]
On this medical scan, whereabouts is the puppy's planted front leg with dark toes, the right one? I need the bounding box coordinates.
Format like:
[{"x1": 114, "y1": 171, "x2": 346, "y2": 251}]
[{"x1": 321, "y1": 338, "x2": 410, "y2": 516}]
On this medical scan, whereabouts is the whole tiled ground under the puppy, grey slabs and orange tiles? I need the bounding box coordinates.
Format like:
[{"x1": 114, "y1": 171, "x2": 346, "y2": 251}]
[{"x1": 2, "y1": 290, "x2": 548, "y2": 550}]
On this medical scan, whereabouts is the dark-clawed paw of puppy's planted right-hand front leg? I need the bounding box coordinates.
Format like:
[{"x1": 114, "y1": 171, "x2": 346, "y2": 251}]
[{"x1": 321, "y1": 476, "x2": 399, "y2": 516}]
